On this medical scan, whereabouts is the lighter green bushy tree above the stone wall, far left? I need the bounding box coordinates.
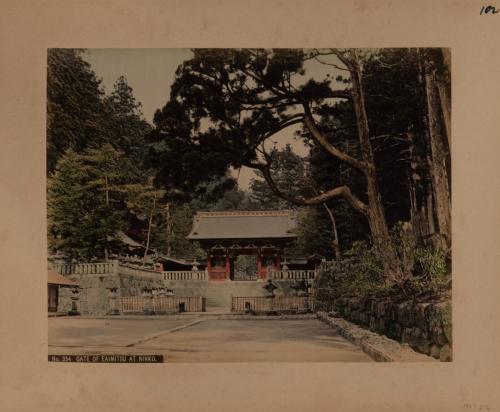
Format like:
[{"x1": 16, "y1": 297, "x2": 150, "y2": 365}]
[{"x1": 48, "y1": 146, "x2": 124, "y2": 260}]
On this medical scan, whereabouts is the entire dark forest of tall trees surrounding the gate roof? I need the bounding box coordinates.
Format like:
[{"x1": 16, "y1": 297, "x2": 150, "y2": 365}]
[{"x1": 47, "y1": 49, "x2": 451, "y2": 296}]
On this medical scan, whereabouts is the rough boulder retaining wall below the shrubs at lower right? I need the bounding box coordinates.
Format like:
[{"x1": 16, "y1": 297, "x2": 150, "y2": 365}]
[{"x1": 333, "y1": 298, "x2": 453, "y2": 361}]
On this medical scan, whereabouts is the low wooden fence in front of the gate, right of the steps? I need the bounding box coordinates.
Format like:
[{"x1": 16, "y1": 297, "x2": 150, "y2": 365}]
[{"x1": 231, "y1": 296, "x2": 311, "y2": 312}]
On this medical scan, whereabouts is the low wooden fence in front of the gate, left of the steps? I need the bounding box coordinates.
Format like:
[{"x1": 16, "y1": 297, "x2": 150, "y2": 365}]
[{"x1": 120, "y1": 296, "x2": 205, "y2": 313}]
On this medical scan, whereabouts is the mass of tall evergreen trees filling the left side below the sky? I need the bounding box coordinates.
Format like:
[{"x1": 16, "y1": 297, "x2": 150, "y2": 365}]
[{"x1": 47, "y1": 49, "x2": 156, "y2": 259}]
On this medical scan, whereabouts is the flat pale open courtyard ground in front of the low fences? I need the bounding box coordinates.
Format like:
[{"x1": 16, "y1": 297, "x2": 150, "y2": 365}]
[{"x1": 48, "y1": 315, "x2": 372, "y2": 362}]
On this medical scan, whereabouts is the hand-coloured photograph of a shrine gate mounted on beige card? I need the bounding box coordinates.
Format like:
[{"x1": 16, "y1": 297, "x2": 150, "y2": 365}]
[{"x1": 46, "y1": 48, "x2": 453, "y2": 363}]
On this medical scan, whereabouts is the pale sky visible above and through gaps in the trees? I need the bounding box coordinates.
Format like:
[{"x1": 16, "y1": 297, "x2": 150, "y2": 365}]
[{"x1": 84, "y1": 49, "x2": 341, "y2": 189}]
